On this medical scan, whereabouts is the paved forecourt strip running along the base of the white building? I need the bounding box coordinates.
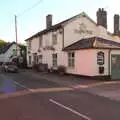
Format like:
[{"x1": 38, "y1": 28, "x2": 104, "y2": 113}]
[{"x1": 20, "y1": 71, "x2": 120, "y2": 101}]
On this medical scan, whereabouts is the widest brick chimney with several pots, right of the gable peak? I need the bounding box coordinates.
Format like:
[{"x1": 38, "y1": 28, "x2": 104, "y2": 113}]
[{"x1": 97, "y1": 8, "x2": 107, "y2": 29}]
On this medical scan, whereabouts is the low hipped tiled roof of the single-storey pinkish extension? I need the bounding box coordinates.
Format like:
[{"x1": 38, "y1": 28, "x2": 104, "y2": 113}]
[{"x1": 63, "y1": 37, "x2": 120, "y2": 51}]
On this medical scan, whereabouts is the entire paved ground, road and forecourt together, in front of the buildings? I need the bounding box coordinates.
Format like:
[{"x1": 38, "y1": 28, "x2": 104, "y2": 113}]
[{"x1": 0, "y1": 70, "x2": 120, "y2": 120}]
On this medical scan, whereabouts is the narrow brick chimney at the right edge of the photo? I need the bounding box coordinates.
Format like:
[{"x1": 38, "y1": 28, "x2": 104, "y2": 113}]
[{"x1": 114, "y1": 14, "x2": 120, "y2": 35}]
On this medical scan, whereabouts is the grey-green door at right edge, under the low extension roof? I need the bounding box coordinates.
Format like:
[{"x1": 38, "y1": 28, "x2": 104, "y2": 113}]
[{"x1": 111, "y1": 55, "x2": 120, "y2": 79}]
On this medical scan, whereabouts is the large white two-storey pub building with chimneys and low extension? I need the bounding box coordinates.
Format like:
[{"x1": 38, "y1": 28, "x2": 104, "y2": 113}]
[{"x1": 26, "y1": 9, "x2": 120, "y2": 79}]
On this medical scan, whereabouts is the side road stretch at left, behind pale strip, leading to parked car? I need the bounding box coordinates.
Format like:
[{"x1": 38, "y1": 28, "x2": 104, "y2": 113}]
[{"x1": 0, "y1": 72, "x2": 60, "y2": 93}]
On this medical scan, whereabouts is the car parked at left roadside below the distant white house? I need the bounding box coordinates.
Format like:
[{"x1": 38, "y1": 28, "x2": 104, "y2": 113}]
[{"x1": 2, "y1": 62, "x2": 18, "y2": 73}]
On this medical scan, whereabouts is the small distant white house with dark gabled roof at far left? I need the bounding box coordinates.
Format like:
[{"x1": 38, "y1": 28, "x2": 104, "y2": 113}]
[{"x1": 0, "y1": 42, "x2": 23, "y2": 63}]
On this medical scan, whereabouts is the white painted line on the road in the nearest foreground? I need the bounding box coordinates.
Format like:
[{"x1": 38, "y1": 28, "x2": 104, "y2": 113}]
[{"x1": 49, "y1": 99, "x2": 92, "y2": 120}]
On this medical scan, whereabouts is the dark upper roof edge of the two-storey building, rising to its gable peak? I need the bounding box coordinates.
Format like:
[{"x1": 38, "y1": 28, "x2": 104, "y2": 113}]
[{"x1": 25, "y1": 12, "x2": 96, "y2": 41}]
